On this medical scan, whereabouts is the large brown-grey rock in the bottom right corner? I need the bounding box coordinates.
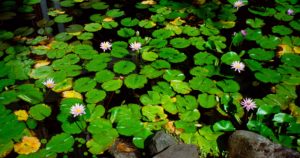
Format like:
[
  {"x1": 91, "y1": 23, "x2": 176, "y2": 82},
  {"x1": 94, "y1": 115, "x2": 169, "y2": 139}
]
[{"x1": 228, "y1": 130, "x2": 300, "y2": 158}]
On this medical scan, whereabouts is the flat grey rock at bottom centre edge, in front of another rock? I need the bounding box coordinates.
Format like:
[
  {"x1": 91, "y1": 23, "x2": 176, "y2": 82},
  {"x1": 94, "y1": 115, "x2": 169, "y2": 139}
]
[{"x1": 153, "y1": 144, "x2": 199, "y2": 158}]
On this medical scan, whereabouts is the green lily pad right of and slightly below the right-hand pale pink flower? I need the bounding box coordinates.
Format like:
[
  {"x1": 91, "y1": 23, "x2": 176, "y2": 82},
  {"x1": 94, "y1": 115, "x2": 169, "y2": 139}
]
[{"x1": 255, "y1": 69, "x2": 282, "y2": 83}]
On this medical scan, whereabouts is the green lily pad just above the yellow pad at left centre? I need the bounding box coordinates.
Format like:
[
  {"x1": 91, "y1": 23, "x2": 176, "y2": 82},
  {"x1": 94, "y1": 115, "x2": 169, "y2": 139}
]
[{"x1": 73, "y1": 77, "x2": 97, "y2": 92}]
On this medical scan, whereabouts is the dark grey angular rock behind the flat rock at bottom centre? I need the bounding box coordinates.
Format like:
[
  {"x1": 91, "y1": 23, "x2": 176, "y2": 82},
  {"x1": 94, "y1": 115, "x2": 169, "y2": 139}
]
[{"x1": 147, "y1": 130, "x2": 177, "y2": 155}]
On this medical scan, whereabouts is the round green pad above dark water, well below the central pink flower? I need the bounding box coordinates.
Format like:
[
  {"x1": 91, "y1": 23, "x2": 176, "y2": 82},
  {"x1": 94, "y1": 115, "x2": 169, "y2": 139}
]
[{"x1": 124, "y1": 74, "x2": 148, "y2": 89}]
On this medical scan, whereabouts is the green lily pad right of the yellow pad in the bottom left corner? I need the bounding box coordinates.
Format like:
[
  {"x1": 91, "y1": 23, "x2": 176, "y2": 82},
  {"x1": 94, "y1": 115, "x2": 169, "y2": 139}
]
[{"x1": 46, "y1": 133, "x2": 75, "y2": 153}]
